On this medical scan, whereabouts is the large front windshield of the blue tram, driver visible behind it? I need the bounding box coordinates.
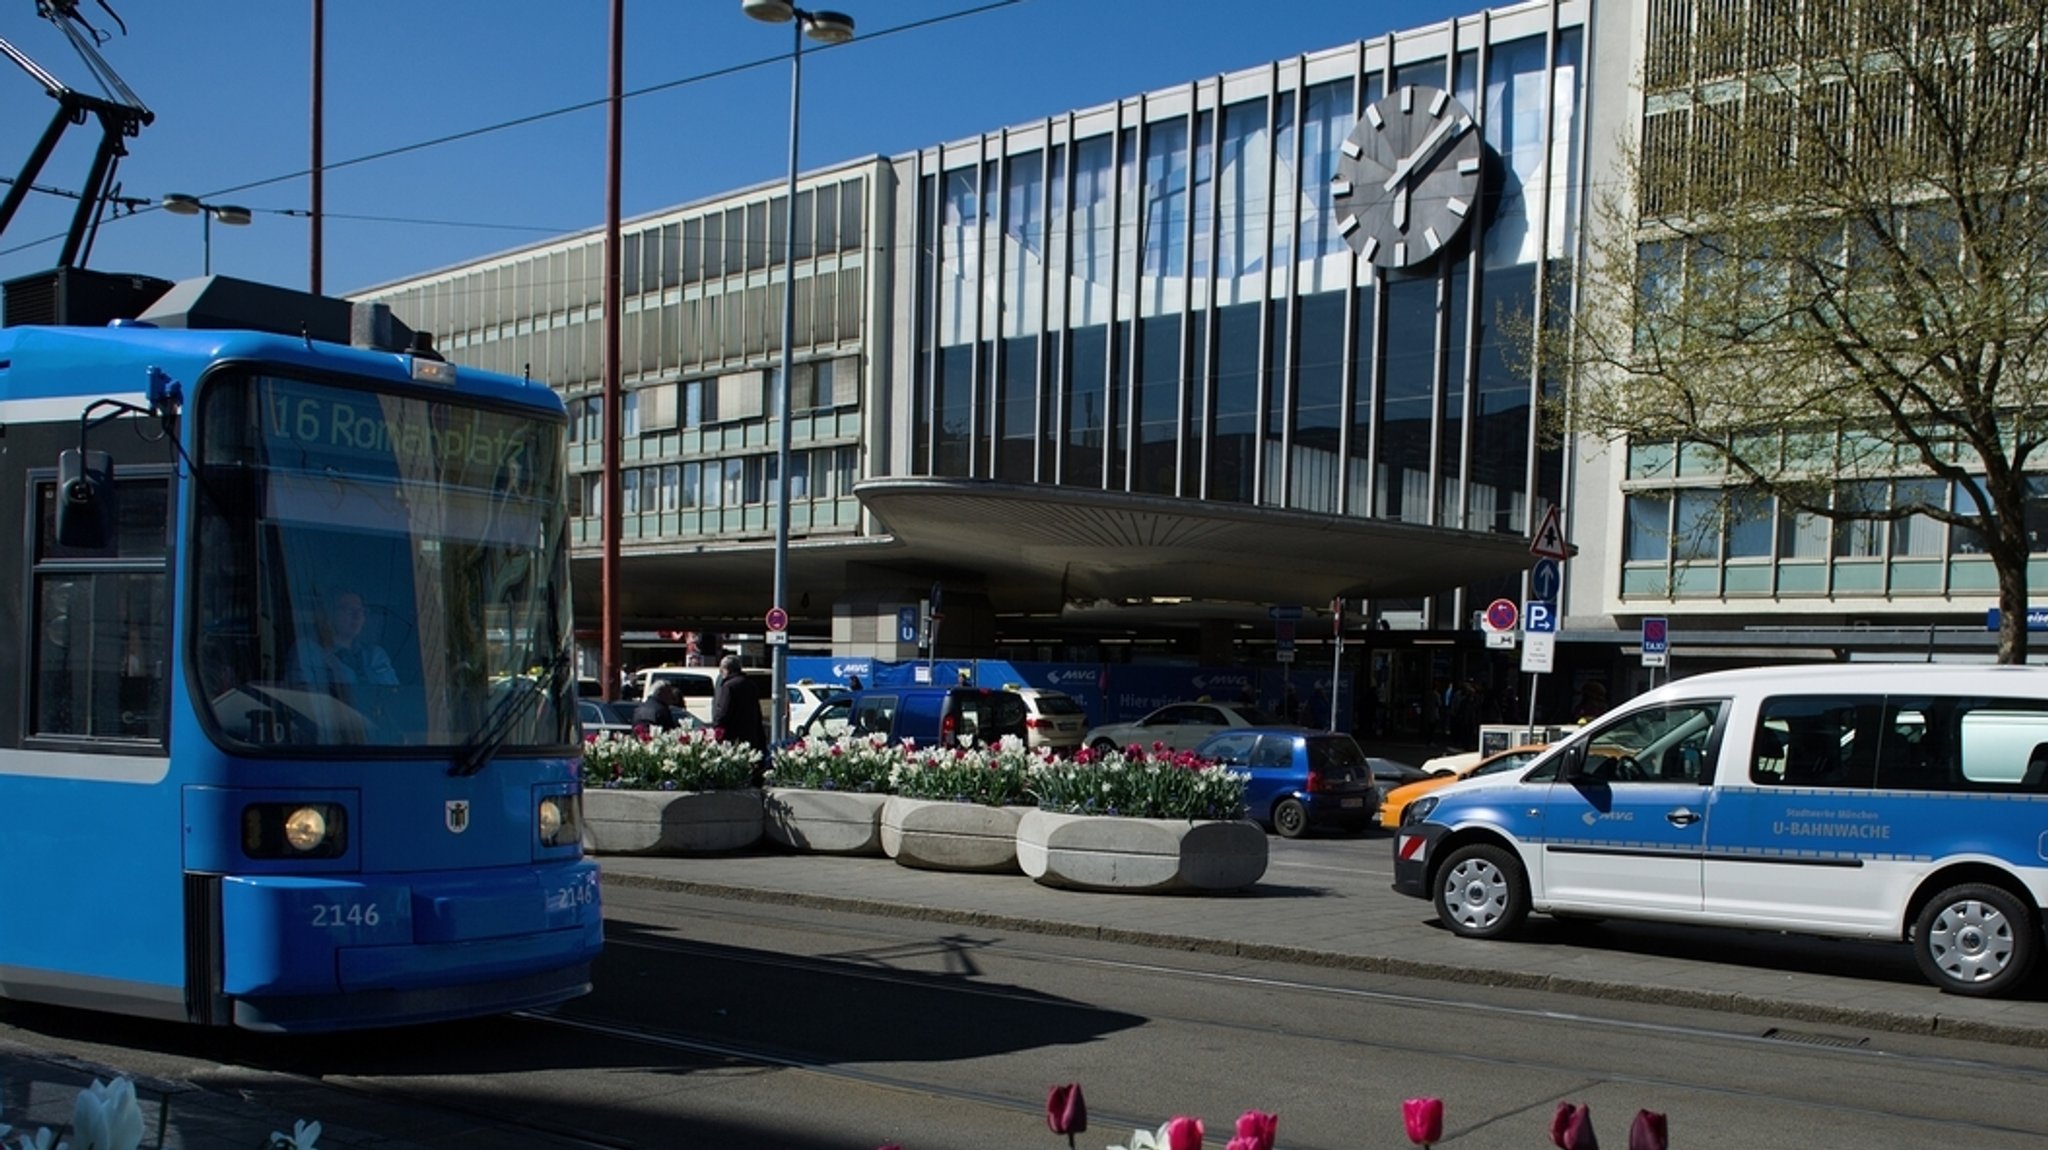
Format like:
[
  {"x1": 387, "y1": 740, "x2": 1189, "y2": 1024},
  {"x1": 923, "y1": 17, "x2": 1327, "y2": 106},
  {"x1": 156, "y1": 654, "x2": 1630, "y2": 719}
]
[{"x1": 188, "y1": 370, "x2": 575, "y2": 753}]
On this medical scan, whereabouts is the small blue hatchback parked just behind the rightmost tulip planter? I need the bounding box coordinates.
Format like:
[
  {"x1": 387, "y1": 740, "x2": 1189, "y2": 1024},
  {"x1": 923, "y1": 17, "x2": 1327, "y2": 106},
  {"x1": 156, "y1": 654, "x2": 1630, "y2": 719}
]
[{"x1": 1194, "y1": 726, "x2": 1380, "y2": 839}]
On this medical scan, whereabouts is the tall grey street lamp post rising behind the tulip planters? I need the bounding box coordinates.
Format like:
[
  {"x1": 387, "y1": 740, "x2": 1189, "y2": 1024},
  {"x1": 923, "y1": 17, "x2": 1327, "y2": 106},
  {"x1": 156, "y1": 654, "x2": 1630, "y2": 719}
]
[{"x1": 739, "y1": 0, "x2": 854, "y2": 739}]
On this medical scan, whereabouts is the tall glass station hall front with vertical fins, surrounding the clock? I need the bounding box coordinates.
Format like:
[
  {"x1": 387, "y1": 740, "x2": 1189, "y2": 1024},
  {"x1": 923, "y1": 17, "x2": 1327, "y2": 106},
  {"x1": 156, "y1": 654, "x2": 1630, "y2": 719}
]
[{"x1": 897, "y1": 8, "x2": 1583, "y2": 601}]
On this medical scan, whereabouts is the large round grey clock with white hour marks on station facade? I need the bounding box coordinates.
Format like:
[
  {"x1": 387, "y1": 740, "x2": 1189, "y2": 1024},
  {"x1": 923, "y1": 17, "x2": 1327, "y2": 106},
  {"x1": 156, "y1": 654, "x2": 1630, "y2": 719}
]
[{"x1": 1331, "y1": 84, "x2": 1485, "y2": 268}]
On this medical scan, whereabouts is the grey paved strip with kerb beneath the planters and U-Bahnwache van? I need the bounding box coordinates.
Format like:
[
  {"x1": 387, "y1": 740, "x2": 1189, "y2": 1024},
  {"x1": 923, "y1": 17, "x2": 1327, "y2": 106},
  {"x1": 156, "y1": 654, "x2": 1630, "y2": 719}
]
[{"x1": 598, "y1": 837, "x2": 2048, "y2": 1048}]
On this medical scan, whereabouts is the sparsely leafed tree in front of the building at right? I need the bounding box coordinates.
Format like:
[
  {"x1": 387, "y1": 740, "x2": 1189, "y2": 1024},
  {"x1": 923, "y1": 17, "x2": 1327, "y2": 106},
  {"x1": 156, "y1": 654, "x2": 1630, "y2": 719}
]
[{"x1": 1532, "y1": 0, "x2": 2048, "y2": 663}]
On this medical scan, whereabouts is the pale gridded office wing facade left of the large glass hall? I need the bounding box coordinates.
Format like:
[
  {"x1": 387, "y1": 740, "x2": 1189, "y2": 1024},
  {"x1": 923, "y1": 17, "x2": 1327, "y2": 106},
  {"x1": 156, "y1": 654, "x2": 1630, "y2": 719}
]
[{"x1": 371, "y1": 164, "x2": 887, "y2": 550}]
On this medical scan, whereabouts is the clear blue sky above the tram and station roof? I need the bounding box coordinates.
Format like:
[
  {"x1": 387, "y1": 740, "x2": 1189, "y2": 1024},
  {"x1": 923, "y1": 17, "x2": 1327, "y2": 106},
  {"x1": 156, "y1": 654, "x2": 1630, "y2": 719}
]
[{"x1": 0, "y1": 0, "x2": 1481, "y2": 295}]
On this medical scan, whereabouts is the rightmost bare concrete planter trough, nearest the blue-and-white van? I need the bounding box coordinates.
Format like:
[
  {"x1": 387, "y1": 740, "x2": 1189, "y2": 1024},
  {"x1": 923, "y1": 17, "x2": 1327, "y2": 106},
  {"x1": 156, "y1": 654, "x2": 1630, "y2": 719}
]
[{"x1": 1018, "y1": 810, "x2": 1266, "y2": 894}]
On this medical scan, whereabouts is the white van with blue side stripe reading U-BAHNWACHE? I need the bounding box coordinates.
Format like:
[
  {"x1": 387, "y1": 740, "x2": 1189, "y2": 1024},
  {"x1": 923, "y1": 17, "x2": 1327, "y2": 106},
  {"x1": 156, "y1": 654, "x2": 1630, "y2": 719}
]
[{"x1": 1395, "y1": 663, "x2": 2048, "y2": 994}]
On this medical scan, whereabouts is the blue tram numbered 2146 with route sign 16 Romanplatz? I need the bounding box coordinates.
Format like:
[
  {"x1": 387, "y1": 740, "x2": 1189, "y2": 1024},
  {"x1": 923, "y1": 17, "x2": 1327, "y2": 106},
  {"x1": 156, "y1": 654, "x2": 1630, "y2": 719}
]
[{"x1": 0, "y1": 276, "x2": 602, "y2": 1031}]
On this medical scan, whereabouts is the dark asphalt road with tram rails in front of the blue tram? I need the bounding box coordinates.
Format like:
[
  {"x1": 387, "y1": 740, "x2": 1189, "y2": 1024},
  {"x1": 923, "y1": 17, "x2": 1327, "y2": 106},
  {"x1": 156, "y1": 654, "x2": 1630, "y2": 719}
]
[{"x1": 0, "y1": 875, "x2": 2048, "y2": 1150}]
